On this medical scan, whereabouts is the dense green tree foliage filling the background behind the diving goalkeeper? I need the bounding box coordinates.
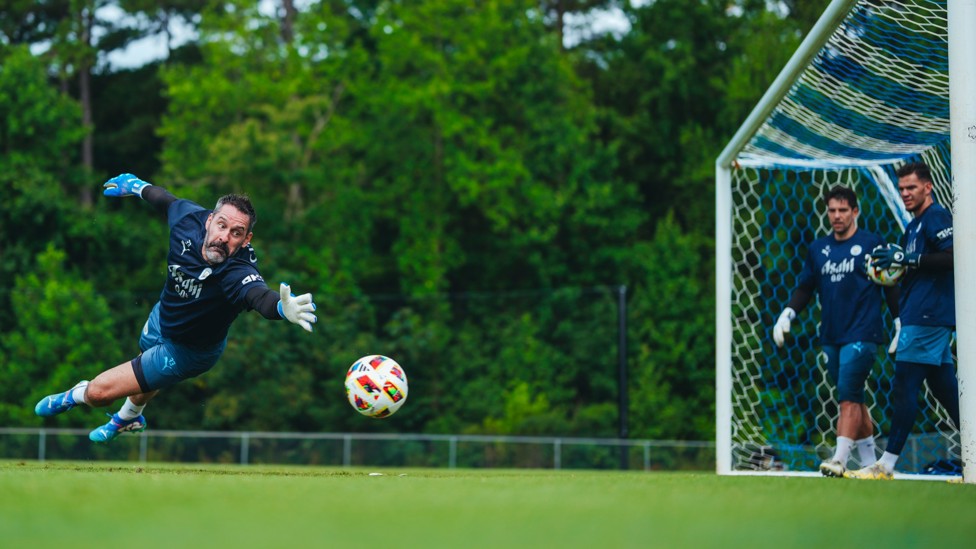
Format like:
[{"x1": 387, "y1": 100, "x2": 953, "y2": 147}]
[{"x1": 0, "y1": 0, "x2": 826, "y2": 439}]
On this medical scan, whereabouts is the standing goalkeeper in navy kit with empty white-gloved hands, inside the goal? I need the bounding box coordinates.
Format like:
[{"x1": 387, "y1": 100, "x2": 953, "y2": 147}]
[{"x1": 773, "y1": 186, "x2": 898, "y2": 477}]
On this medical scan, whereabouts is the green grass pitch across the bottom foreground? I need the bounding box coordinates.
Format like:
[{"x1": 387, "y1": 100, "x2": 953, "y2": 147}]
[{"x1": 0, "y1": 461, "x2": 976, "y2": 549}]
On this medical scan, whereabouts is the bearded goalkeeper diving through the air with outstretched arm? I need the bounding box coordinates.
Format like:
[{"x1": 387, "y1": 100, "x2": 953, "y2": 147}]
[{"x1": 34, "y1": 174, "x2": 317, "y2": 442}]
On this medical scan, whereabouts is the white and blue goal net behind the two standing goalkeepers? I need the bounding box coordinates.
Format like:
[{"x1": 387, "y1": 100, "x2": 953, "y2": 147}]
[{"x1": 716, "y1": 0, "x2": 961, "y2": 473}]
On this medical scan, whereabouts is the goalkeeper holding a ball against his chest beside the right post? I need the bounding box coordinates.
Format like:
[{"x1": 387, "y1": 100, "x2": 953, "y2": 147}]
[{"x1": 844, "y1": 162, "x2": 959, "y2": 480}]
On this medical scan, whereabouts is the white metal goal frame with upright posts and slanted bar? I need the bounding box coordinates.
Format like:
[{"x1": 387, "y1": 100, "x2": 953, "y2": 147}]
[{"x1": 715, "y1": 0, "x2": 976, "y2": 483}]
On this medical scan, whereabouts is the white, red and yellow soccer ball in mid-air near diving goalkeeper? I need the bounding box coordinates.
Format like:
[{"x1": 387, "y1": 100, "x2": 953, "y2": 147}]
[{"x1": 346, "y1": 355, "x2": 407, "y2": 418}]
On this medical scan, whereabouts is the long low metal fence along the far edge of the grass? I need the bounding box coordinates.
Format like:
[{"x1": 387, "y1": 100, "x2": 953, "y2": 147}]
[{"x1": 0, "y1": 427, "x2": 715, "y2": 471}]
